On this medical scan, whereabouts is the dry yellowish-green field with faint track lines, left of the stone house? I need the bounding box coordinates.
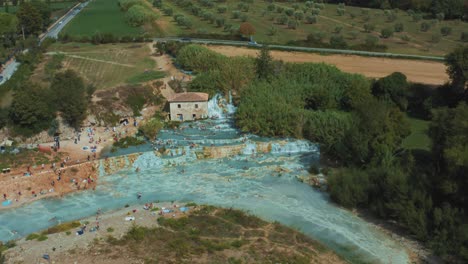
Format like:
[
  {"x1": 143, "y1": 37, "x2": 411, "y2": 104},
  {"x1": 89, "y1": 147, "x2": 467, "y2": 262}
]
[{"x1": 45, "y1": 43, "x2": 164, "y2": 89}]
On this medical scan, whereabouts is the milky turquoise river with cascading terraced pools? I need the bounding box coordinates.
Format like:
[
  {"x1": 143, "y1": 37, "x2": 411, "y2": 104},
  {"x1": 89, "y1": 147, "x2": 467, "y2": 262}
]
[{"x1": 0, "y1": 96, "x2": 409, "y2": 263}]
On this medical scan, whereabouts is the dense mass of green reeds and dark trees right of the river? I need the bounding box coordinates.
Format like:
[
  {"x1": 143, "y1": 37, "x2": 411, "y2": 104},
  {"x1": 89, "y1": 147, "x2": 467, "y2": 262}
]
[{"x1": 174, "y1": 44, "x2": 468, "y2": 262}]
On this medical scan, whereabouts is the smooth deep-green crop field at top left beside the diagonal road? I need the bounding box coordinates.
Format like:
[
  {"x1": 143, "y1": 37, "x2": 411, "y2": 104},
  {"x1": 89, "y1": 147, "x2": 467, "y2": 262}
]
[{"x1": 62, "y1": 0, "x2": 144, "y2": 37}]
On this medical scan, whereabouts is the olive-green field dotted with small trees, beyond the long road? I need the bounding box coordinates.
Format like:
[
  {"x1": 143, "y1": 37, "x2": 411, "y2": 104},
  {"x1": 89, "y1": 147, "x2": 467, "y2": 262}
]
[{"x1": 160, "y1": 0, "x2": 468, "y2": 55}]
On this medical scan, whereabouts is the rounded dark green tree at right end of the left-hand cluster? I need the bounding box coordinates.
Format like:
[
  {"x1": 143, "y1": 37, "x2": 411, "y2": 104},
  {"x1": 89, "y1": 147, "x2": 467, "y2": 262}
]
[{"x1": 50, "y1": 70, "x2": 88, "y2": 128}]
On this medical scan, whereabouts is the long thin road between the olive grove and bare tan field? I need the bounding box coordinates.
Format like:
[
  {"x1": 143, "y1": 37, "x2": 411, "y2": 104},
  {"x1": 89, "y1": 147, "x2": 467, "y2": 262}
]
[{"x1": 154, "y1": 37, "x2": 444, "y2": 61}]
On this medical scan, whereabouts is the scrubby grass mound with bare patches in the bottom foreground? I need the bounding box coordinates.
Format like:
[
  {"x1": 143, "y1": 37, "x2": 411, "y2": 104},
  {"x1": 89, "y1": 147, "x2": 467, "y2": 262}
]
[{"x1": 59, "y1": 206, "x2": 344, "y2": 263}]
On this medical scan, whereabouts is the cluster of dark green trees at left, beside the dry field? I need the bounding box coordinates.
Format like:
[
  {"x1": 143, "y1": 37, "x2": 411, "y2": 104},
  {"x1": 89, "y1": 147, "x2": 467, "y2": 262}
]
[{"x1": 0, "y1": 39, "x2": 91, "y2": 136}]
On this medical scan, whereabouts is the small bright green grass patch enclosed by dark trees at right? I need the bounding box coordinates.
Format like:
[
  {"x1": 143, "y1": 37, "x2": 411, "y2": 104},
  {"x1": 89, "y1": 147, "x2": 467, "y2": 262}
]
[{"x1": 402, "y1": 118, "x2": 431, "y2": 151}]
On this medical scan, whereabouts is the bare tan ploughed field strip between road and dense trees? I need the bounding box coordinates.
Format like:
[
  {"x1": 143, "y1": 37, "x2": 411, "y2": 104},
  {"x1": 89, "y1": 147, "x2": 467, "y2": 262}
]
[{"x1": 208, "y1": 45, "x2": 449, "y2": 85}]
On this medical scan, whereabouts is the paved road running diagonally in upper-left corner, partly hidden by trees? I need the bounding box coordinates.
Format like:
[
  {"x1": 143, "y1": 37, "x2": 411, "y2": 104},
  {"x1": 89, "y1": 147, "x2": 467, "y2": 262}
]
[{"x1": 0, "y1": 2, "x2": 88, "y2": 85}]
